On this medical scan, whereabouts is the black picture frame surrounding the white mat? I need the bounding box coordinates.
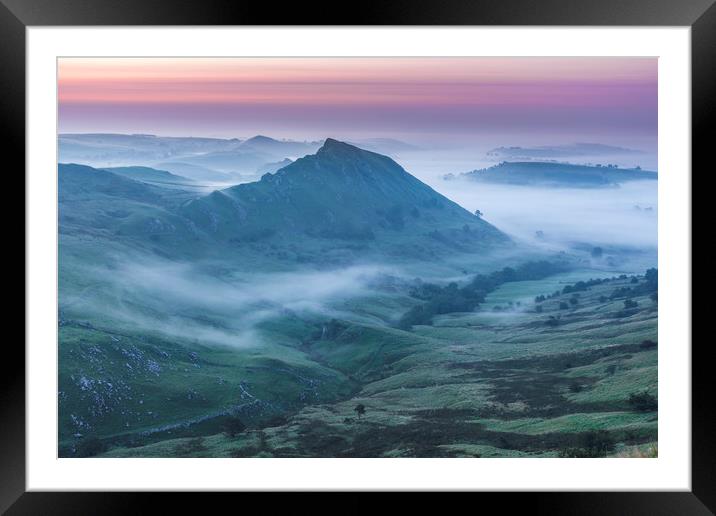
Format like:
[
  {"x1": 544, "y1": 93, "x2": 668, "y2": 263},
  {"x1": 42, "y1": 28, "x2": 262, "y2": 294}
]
[{"x1": 0, "y1": 0, "x2": 716, "y2": 515}]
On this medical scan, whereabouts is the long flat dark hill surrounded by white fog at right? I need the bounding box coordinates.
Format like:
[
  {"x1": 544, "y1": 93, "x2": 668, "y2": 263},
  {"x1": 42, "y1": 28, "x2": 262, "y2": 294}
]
[{"x1": 456, "y1": 161, "x2": 657, "y2": 188}]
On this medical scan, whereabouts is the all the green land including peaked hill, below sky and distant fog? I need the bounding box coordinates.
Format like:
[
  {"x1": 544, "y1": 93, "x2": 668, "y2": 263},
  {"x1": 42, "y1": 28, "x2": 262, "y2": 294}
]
[{"x1": 58, "y1": 139, "x2": 658, "y2": 457}]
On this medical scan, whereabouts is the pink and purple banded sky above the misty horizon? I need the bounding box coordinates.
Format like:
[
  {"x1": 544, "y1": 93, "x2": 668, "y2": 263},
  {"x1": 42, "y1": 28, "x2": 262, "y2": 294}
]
[{"x1": 58, "y1": 58, "x2": 657, "y2": 145}]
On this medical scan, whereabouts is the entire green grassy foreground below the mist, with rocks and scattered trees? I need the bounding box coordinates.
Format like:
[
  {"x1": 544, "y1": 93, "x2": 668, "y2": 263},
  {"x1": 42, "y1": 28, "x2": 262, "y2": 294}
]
[{"x1": 70, "y1": 272, "x2": 658, "y2": 457}]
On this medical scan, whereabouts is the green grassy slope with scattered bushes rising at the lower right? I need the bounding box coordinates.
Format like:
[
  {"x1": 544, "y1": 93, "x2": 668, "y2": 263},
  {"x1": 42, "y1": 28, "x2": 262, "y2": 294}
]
[{"x1": 96, "y1": 272, "x2": 657, "y2": 457}]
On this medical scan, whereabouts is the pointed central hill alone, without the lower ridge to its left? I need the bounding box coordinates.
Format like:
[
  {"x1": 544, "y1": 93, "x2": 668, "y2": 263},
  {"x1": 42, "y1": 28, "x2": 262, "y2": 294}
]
[{"x1": 182, "y1": 139, "x2": 507, "y2": 248}]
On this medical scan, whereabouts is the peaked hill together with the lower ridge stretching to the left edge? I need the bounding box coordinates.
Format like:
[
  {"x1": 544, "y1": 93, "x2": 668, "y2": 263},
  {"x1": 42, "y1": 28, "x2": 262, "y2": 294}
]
[{"x1": 59, "y1": 139, "x2": 510, "y2": 269}]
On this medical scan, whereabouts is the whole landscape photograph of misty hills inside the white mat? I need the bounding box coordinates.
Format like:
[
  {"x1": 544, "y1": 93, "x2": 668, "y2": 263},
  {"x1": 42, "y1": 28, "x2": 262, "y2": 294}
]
[{"x1": 58, "y1": 57, "x2": 666, "y2": 459}]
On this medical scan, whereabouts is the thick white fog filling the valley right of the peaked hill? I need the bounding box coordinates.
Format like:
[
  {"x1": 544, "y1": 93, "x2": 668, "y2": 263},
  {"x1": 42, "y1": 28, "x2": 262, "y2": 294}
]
[{"x1": 386, "y1": 145, "x2": 658, "y2": 265}]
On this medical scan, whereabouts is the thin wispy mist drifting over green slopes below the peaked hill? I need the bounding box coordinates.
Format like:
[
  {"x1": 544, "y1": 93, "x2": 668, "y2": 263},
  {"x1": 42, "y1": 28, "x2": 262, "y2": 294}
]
[{"x1": 60, "y1": 255, "x2": 397, "y2": 348}]
